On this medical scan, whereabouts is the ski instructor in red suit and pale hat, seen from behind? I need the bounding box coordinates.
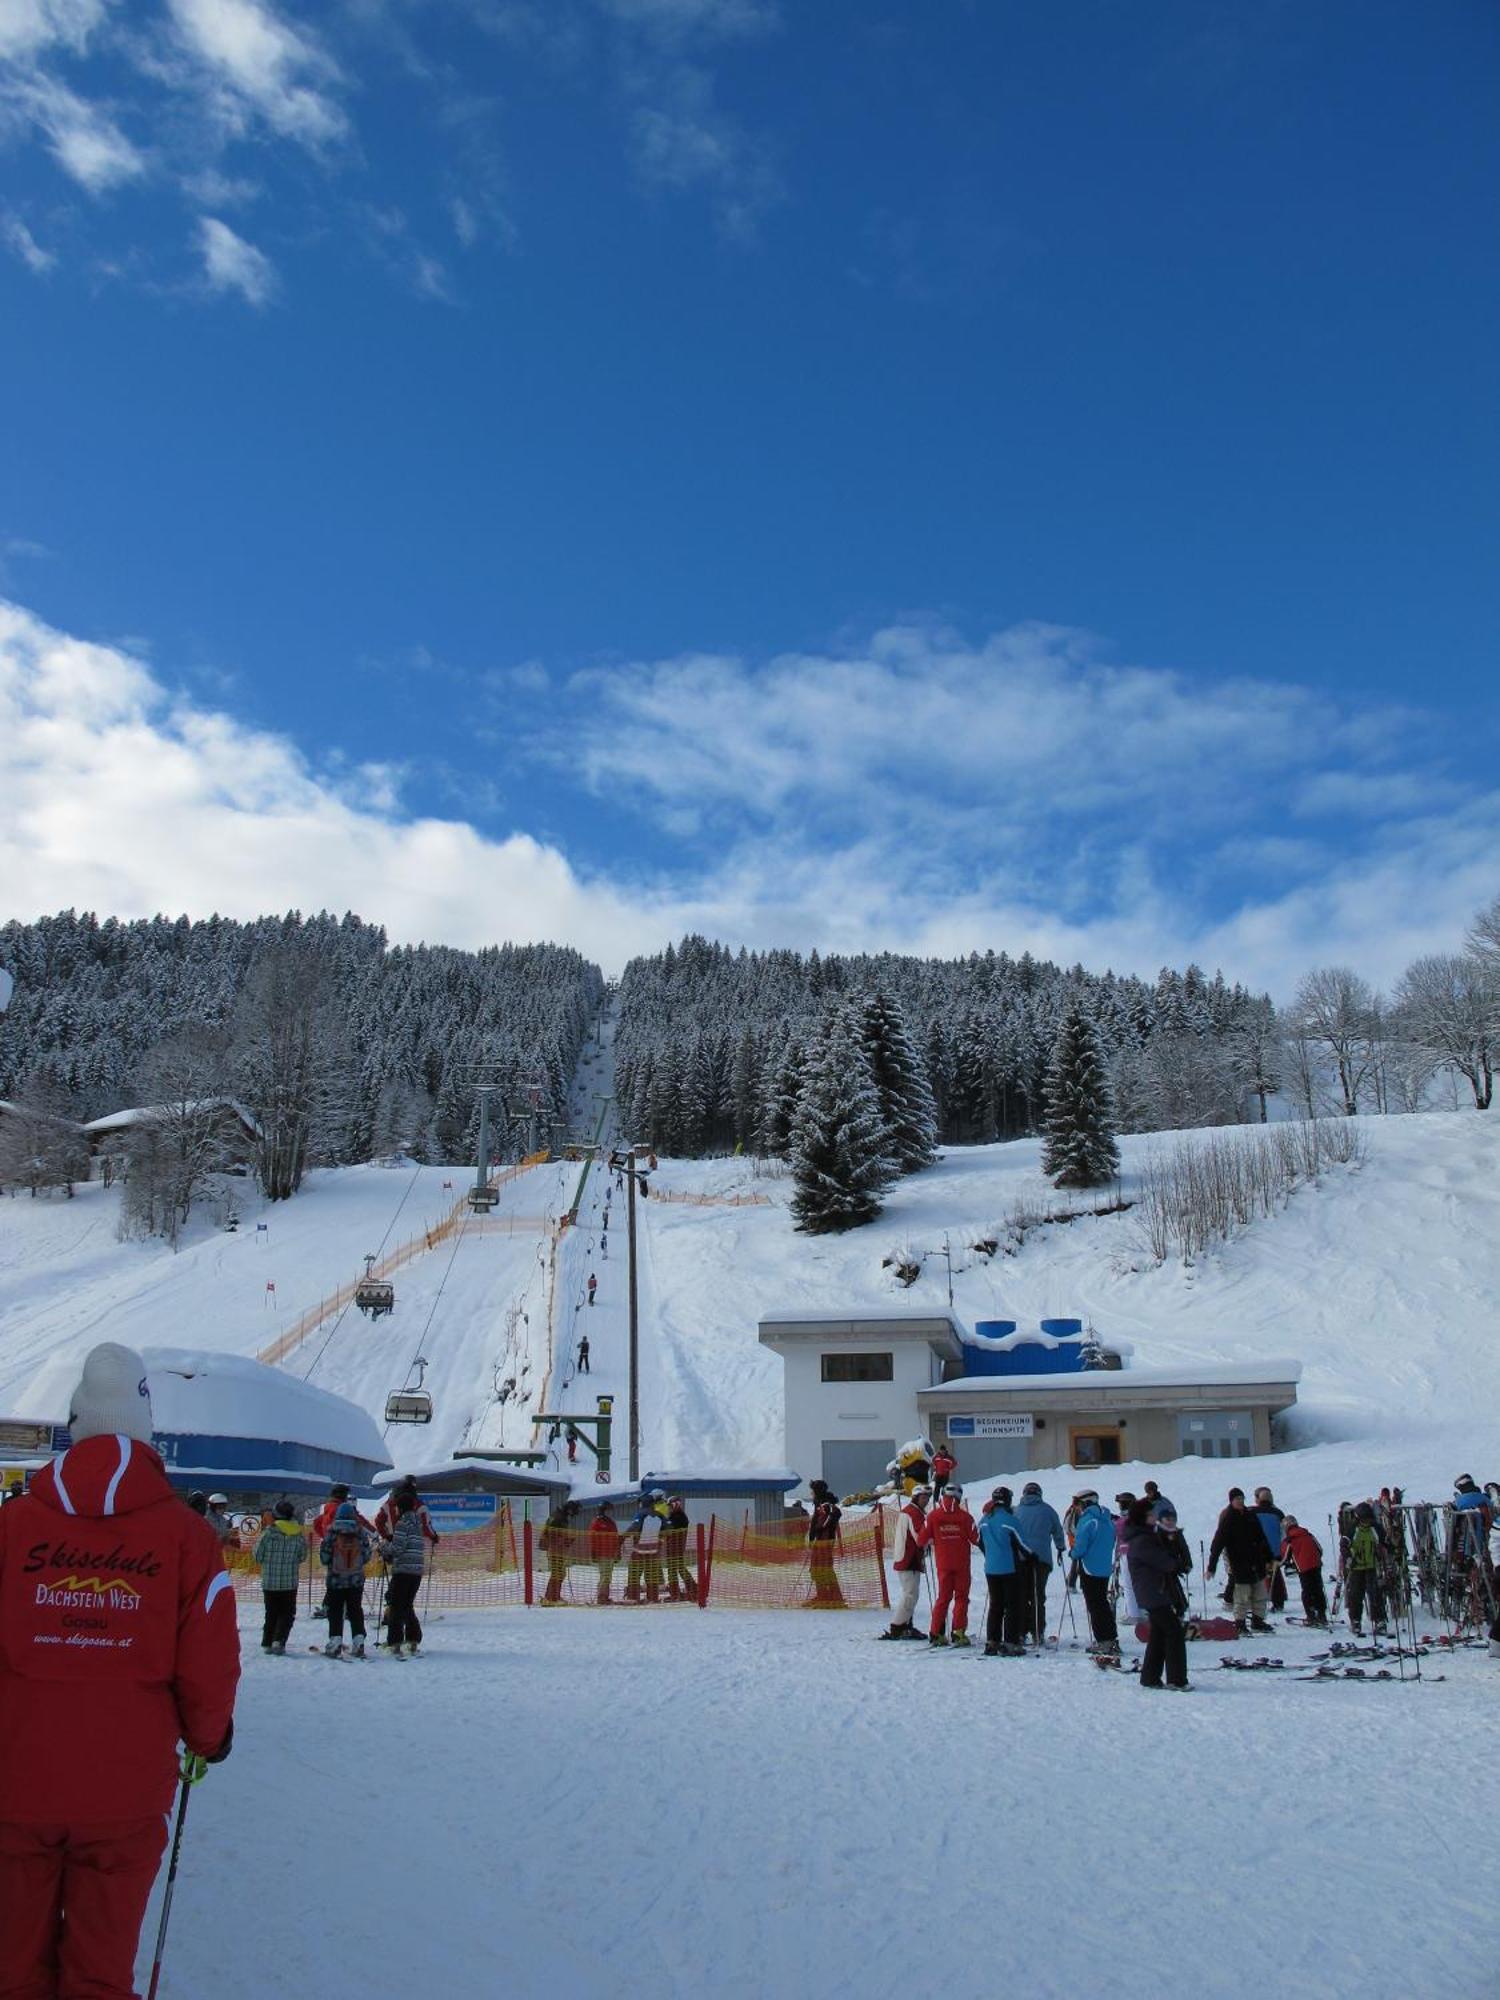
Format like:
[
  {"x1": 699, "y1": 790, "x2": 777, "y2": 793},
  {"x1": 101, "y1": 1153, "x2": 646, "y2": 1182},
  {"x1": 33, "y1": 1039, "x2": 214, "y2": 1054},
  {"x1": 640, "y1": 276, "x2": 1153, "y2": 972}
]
[{"x1": 0, "y1": 1342, "x2": 240, "y2": 2000}]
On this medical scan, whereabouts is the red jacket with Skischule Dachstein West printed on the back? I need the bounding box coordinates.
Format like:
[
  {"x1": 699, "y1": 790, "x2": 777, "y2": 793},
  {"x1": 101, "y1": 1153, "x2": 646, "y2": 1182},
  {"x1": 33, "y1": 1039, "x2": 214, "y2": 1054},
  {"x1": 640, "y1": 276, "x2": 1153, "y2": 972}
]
[{"x1": 0, "y1": 1436, "x2": 240, "y2": 1826}]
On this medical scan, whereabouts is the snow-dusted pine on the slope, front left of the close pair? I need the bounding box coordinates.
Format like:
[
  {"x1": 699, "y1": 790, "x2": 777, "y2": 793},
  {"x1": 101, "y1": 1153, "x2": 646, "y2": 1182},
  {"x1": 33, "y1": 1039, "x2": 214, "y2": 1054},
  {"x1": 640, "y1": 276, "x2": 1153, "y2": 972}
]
[{"x1": 790, "y1": 1002, "x2": 894, "y2": 1236}]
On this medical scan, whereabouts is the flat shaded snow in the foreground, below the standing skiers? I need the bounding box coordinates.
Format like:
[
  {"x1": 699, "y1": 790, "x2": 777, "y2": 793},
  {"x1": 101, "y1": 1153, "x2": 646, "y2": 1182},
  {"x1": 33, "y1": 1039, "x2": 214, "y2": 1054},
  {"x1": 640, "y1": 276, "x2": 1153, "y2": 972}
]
[{"x1": 159, "y1": 1608, "x2": 1500, "y2": 2000}]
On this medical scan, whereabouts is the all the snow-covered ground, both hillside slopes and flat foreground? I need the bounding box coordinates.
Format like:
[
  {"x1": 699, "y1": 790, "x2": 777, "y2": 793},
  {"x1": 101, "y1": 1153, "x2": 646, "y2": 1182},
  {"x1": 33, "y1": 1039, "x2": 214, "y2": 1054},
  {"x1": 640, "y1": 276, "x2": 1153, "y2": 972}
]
[{"x1": 0, "y1": 1104, "x2": 1500, "y2": 2000}]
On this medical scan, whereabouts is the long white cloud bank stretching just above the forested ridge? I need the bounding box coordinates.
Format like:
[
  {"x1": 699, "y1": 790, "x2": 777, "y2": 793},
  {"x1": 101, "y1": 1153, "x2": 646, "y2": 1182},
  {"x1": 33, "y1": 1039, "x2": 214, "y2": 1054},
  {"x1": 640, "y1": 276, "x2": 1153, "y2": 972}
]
[{"x1": 0, "y1": 600, "x2": 1500, "y2": 998}]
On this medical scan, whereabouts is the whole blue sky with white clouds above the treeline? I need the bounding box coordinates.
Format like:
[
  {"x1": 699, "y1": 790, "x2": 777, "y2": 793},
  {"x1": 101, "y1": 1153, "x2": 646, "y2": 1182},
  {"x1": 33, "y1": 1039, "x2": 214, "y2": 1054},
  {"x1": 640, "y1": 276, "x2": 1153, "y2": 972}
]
[{"x1": 0, "y1": 0, "x2": 1500, "y2": 992}]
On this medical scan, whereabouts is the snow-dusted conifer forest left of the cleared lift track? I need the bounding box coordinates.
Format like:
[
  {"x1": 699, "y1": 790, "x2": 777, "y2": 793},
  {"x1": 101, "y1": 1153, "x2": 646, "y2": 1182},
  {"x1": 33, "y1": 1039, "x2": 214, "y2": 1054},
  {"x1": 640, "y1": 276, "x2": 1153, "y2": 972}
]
[{"x1": 0, "y1": 910, "x2": 604, "y2": 1194}]
